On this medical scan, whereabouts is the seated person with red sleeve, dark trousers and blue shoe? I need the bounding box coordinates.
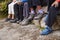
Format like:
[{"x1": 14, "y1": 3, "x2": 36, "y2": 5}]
[{"x1": 40, "y1": 0, "x2": 60, "y2": 35}]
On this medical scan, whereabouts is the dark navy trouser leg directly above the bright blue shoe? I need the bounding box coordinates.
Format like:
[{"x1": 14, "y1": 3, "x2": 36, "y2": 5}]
[{"x1": 47, "y1": 7, "x2": 57, "y2": 27}]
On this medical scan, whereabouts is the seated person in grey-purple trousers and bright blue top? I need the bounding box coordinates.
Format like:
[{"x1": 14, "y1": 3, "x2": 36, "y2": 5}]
[{"x1": 17, "y1": 0, "x2": 29, "y2": 23}]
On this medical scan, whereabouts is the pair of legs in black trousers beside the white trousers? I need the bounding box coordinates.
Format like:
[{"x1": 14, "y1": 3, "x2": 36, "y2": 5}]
[{"x1": 14, "y1": 3, "x2": 23, "y2": 22}]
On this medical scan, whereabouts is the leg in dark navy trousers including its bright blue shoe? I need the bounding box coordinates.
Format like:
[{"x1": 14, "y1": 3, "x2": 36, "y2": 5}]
[{"x1": 41, "y1": 0, "x2": 57, "y2": 35}]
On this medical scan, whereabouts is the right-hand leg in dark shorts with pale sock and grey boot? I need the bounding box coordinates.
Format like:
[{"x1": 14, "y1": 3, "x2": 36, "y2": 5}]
[{"x1": 34, "y1": 0, "x2": 43, "y2": 20}]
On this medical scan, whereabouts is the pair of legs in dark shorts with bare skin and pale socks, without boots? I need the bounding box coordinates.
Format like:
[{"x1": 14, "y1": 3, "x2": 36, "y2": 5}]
[{"x1": 29, "y1": 0, "x2": 42, "y2": 13}]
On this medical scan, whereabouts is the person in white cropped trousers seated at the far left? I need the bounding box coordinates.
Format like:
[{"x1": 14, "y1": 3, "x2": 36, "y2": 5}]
[{"x1": 6, "y1": 0, "x2": 16, "y2": 21}]
